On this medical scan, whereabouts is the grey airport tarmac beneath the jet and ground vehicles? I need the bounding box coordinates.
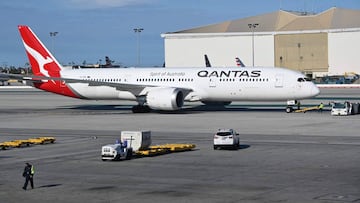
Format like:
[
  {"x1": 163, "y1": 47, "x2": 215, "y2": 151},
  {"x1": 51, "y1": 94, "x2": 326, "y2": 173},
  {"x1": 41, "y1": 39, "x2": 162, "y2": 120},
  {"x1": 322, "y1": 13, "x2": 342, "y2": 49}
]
[{"x1": 0, "y1": 88, "x2": 360, "y2": 203}]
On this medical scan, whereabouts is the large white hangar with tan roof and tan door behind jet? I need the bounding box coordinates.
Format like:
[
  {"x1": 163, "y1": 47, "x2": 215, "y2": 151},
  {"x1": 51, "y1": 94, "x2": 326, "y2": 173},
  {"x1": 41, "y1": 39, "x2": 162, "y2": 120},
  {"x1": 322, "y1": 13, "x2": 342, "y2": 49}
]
[{"x1": 162, "y1": 7, "x2": 360, "y2": 76}]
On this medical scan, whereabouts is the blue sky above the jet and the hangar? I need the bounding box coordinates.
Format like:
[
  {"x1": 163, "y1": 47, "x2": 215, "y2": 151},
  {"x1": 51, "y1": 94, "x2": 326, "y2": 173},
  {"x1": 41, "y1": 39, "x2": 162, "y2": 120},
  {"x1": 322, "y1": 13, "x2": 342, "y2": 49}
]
[{"x1": 0, "y1": 0, "x2": 360, "y2": 67}]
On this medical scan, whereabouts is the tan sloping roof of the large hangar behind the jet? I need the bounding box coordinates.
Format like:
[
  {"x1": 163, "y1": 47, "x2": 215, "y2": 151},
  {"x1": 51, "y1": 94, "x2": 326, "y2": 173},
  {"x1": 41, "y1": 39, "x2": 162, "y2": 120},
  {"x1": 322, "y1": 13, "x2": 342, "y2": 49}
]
[{"x1": 168, "y1": 7, "x2": 360, "y2": 34}]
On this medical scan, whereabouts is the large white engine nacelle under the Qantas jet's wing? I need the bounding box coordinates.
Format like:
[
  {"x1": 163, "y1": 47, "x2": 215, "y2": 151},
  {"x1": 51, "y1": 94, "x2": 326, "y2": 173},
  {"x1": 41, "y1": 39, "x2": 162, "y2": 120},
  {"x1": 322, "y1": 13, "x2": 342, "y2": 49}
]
[{"x1": 146, "y1": 87, "x2": 184, "y2": 110}]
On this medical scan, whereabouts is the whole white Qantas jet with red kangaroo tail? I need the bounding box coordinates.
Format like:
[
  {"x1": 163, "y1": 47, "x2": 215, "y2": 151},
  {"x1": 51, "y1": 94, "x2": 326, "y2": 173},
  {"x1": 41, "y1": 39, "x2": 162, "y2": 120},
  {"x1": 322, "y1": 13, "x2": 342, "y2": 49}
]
[{"x1": 4, "y1": 25, "x2": 320, "y2": 113}]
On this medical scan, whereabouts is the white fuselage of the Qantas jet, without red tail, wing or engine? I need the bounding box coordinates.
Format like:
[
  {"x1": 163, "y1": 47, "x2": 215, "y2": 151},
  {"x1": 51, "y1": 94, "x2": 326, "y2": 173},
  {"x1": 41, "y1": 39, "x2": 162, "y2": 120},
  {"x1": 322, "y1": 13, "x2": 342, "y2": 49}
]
[{"x1": 61, "y1": 67, "x2": 319, "y2": 101}]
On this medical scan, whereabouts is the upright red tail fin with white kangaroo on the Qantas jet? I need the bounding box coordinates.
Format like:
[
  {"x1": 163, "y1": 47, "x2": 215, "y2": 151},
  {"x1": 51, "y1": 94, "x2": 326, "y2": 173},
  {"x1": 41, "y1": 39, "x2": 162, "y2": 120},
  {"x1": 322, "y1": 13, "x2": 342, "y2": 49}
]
[{"x1": 18, "y1": 25, "x2": 62, "y2": 77}]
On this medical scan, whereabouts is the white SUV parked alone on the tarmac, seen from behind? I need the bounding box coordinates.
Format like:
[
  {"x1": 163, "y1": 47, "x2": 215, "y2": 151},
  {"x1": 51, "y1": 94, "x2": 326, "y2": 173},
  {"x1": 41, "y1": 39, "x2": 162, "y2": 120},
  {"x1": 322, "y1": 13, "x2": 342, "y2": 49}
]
[{"x1": 214, "y1": 129, "x2": 240, "y2": 149}]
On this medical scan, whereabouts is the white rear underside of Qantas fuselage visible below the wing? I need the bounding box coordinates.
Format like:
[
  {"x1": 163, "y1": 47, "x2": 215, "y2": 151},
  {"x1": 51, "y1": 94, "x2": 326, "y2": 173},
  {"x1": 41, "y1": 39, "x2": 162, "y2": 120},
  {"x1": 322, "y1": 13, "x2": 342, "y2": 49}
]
[{"x1": 69, "y1": 83, "x2": 136, "y2": 100}]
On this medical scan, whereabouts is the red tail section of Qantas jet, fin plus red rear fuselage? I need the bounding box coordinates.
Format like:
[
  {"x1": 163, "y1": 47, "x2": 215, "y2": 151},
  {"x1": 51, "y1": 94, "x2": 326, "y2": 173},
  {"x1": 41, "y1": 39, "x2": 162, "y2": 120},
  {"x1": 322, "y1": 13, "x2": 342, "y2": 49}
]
[{"x1": 18, "y1": 25, "x2": 79, "y2": 98}]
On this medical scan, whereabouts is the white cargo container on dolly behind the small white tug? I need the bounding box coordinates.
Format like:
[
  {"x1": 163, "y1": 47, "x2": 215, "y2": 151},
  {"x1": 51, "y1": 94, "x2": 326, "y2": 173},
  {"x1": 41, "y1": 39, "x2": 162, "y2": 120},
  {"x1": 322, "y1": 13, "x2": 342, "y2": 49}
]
[{"x1": 121, "y1": 131, "x2": 151, "y2": 151}]
